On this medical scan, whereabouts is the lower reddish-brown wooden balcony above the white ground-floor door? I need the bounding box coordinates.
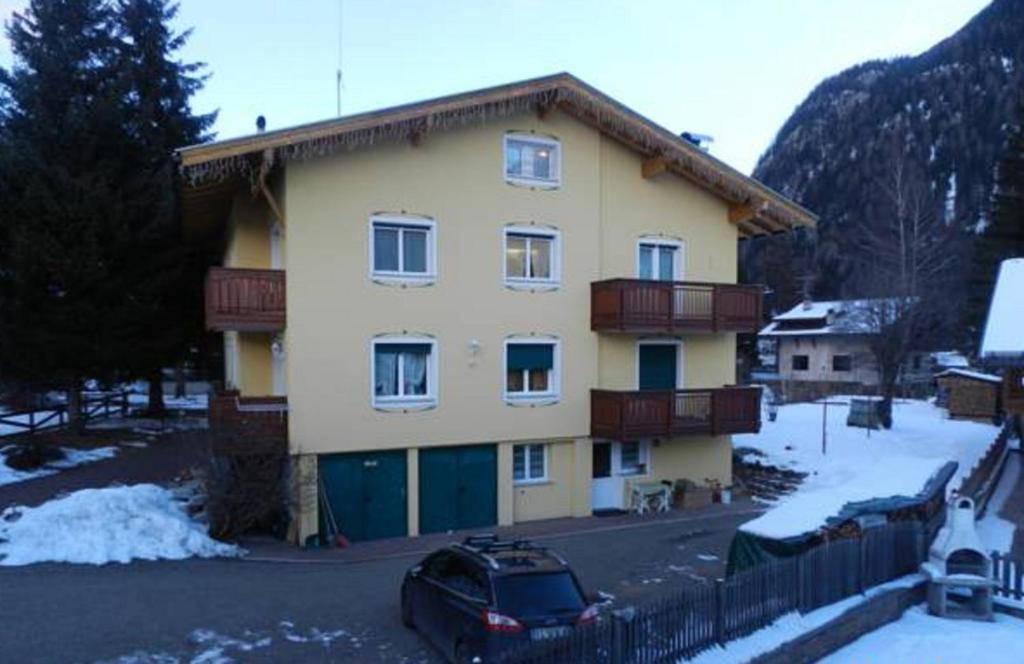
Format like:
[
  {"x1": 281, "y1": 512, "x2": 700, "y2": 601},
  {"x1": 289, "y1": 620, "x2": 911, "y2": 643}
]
[{"x1": 590, "y1": 387, "x2": 761, "y2": 441}]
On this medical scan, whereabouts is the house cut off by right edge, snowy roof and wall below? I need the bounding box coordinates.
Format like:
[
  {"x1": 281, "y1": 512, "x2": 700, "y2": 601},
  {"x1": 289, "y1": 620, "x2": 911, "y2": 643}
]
[{"x1": 981, "y1": 258, "x2": 1024, "y2": 416}]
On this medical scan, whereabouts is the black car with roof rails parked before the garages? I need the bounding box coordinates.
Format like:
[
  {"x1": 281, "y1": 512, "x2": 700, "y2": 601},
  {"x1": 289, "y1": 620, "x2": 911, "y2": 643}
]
[{"x1": 401, "y1": 535, "x2": 598, "y2": 664}]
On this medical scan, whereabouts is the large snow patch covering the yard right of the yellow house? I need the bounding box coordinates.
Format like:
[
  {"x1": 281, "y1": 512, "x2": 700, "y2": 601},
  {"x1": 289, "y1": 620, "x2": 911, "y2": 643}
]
[{"x1": 732, "y1": 397, "x2": 998, "y2": 538}]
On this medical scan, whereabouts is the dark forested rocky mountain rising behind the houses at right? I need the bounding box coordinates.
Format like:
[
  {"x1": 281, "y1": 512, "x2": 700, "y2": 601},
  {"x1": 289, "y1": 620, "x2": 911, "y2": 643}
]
[{"x1": 743, "y1": 0, "x2": 1024, "y2": 325}]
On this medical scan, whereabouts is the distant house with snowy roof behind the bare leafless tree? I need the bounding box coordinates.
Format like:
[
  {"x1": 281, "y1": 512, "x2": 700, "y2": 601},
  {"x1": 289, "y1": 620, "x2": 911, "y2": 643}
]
[{"x1": 758, "y1": 300, "x2": 932, "y2": 401}]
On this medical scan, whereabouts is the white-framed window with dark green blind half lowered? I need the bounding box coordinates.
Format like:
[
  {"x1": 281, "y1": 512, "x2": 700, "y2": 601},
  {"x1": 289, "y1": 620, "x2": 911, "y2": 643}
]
[{"x1": 505, "y1": 337, "x2": 561, "y2": 403}]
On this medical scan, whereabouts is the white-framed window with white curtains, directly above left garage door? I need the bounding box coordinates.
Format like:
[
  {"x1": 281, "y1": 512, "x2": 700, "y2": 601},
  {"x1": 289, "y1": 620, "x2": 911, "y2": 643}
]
[{"x1": 370, "y1": 335, "x2": 437, "y2": 409}]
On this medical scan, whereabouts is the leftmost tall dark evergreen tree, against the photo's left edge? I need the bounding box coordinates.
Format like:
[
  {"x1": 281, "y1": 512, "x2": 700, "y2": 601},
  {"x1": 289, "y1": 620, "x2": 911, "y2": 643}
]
[{"x1": 0, "y1": 0, "x2": 127, "y2": 428}]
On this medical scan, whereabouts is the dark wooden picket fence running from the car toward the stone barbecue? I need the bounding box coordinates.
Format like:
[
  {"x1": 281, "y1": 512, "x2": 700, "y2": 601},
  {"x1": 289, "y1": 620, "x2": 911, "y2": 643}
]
[{"x1": 498, "y1": 522, "x2": 925, "y2": 664}]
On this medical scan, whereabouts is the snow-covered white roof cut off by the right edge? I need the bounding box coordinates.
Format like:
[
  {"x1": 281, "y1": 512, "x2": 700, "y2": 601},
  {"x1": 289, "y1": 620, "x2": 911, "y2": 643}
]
[{"x1": 981, "y1": 258, "x2": 1024, "y2": 364}]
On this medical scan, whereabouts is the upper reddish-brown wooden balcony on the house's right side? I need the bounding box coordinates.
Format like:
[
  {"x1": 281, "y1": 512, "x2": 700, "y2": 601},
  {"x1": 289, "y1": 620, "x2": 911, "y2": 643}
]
[{"x1": 590, "y1": 279, "x2": 763, "y2": 334}]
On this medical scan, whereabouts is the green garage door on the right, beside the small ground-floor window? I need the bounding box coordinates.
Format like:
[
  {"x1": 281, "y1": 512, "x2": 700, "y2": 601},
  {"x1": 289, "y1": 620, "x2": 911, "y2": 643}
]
[{"x1": 420, "y1": 445, "x2": 498, "y2": 534}]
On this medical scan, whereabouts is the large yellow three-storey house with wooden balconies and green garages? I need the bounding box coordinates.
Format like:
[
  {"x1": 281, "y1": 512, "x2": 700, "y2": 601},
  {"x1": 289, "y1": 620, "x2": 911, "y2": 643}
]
[{"x1": 178, "y1": 74, "x2": 815, "y2": 541}]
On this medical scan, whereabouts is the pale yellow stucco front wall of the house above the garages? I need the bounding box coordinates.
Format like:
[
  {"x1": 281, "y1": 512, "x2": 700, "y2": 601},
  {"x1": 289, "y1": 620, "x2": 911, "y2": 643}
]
[{"x1": 285, "y1": 113, "x2": 736, "y2": 453}]
